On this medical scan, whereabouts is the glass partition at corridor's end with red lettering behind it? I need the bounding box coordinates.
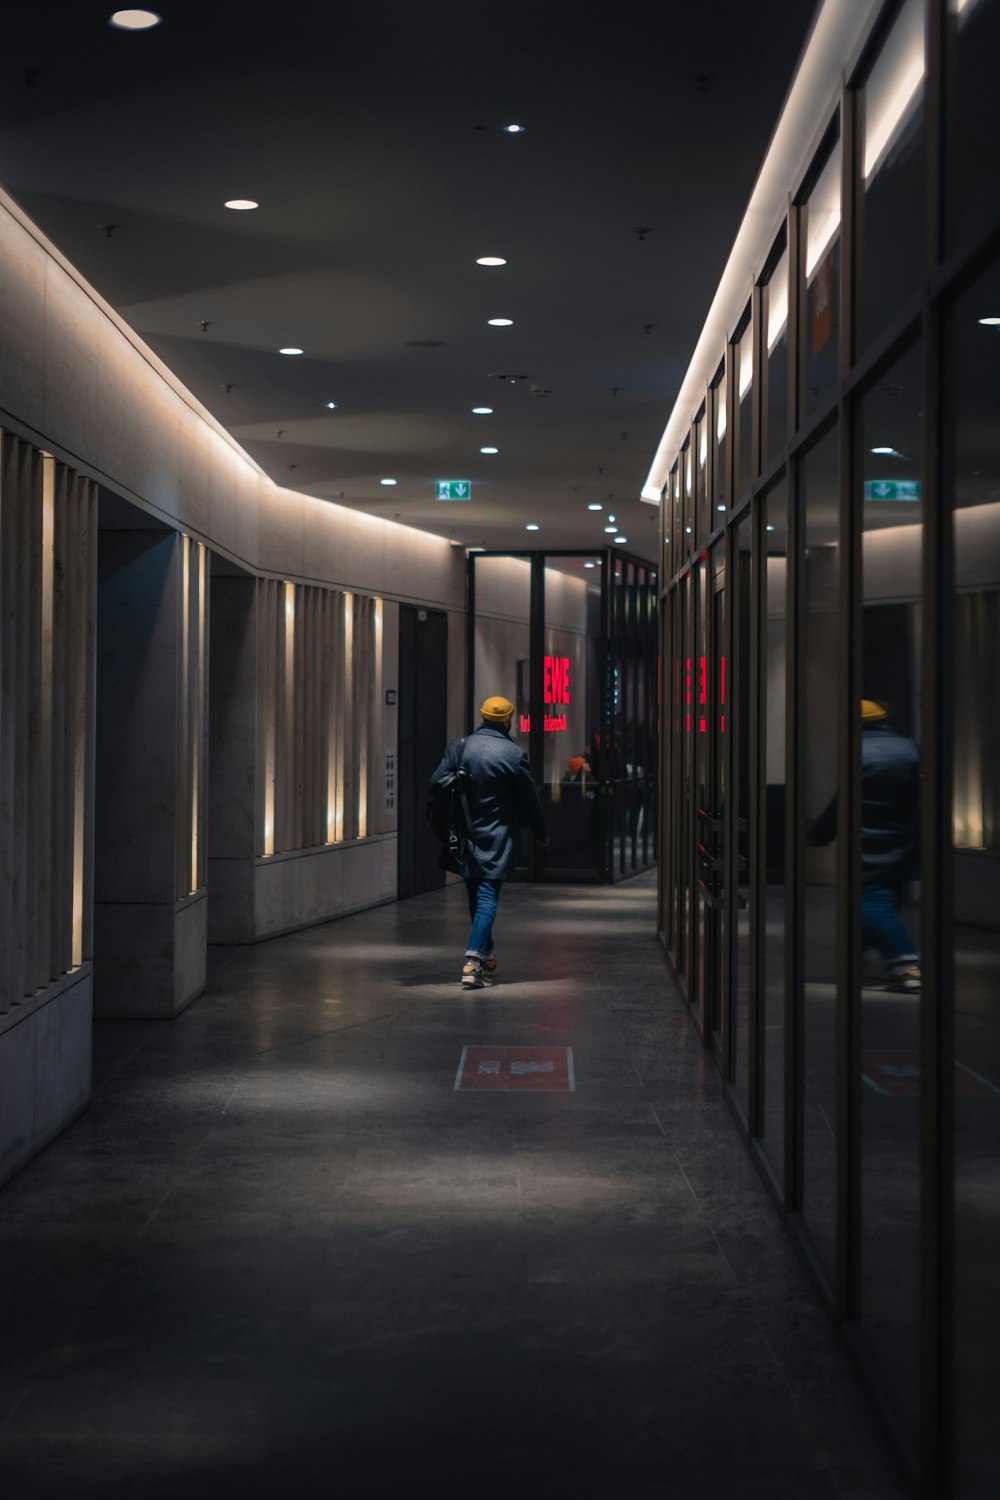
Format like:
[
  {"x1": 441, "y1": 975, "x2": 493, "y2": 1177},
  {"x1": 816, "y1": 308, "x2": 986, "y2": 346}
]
[{"x1": 466, "y1": 549, "x2": 660, "y2": 881}]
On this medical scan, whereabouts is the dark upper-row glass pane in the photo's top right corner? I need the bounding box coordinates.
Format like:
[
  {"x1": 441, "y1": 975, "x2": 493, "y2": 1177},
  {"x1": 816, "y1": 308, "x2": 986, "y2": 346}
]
[{"x1": 945, "y1": 0, "x2": 1000, "y2": 249}]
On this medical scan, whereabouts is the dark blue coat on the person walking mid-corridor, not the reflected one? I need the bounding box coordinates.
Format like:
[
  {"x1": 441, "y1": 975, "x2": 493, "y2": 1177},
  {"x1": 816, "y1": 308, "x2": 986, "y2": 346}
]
[{"x1": 430, "y1": 725, "x2": 549, "y2": 881}]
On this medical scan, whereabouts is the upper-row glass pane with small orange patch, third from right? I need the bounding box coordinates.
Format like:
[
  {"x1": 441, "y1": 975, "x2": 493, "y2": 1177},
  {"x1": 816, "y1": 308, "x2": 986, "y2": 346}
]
[{"x1": 802, "y1": 141, "x2": 841, "y2": 417}]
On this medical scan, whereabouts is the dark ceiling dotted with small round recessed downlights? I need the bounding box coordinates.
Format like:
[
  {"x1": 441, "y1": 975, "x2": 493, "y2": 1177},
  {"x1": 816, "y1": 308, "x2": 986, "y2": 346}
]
[{"x1": 0, "y1": 0, "x2": 813, "y2": 560}]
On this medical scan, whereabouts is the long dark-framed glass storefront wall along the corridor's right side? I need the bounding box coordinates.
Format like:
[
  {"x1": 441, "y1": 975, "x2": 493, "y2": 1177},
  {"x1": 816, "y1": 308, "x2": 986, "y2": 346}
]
[{"x1": 660, "y1": 0, "x2": 1000, "y2": 1500}]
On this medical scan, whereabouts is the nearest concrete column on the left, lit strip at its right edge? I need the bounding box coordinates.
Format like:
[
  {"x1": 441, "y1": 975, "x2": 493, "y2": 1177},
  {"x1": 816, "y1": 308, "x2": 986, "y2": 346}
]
[{"x1": 94, "y1": 531, "x2": 207, "y2": 1016}]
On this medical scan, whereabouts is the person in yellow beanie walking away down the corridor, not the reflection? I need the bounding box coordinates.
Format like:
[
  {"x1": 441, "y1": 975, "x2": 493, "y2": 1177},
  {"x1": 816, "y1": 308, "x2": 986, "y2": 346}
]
[{"x1": 430, "y1": 698, "x2": 549, "y2": 990}]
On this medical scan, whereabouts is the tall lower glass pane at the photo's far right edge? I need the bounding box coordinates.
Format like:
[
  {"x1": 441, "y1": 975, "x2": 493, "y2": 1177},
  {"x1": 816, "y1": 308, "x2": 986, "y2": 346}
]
[{"x1": 952, "y1": 252, "x2": 1000, "y2": 1500}]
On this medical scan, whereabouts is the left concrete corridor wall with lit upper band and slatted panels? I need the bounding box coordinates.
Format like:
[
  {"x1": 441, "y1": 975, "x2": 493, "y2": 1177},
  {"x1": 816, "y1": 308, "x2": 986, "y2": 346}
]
[{"x1": 0, "y1": 181, "x2": 465, "y2": 1181}]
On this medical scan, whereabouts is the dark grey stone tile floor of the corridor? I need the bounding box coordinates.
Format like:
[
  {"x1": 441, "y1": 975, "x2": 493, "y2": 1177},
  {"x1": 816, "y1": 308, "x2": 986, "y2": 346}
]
[{"x1": 0, "y1": 876, "x2": 909, "y2": 1500}]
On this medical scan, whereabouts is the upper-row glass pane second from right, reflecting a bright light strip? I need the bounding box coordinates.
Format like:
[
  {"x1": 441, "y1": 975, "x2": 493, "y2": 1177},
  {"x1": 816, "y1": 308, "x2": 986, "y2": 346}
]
[{"x1": 861, "y1": 0, "x2": 925, "y2": 344}]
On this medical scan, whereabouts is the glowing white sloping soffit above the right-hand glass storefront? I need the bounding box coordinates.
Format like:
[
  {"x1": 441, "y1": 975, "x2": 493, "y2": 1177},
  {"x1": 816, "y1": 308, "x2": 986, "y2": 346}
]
[{"x1": 642, "y1": 0, "x2": 871, "y2": 506}]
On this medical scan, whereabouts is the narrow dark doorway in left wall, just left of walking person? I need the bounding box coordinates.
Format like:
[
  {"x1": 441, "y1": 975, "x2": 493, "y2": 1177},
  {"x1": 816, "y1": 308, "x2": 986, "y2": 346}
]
[{"x1": 396, "y1": 605, "x2": 448, "y2": 900}]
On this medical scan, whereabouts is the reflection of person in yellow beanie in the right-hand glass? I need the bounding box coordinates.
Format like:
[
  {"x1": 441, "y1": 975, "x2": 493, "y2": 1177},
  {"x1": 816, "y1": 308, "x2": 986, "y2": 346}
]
[{"x1": 810, "y1": 698, "x2": 921, "y2": 993}]
